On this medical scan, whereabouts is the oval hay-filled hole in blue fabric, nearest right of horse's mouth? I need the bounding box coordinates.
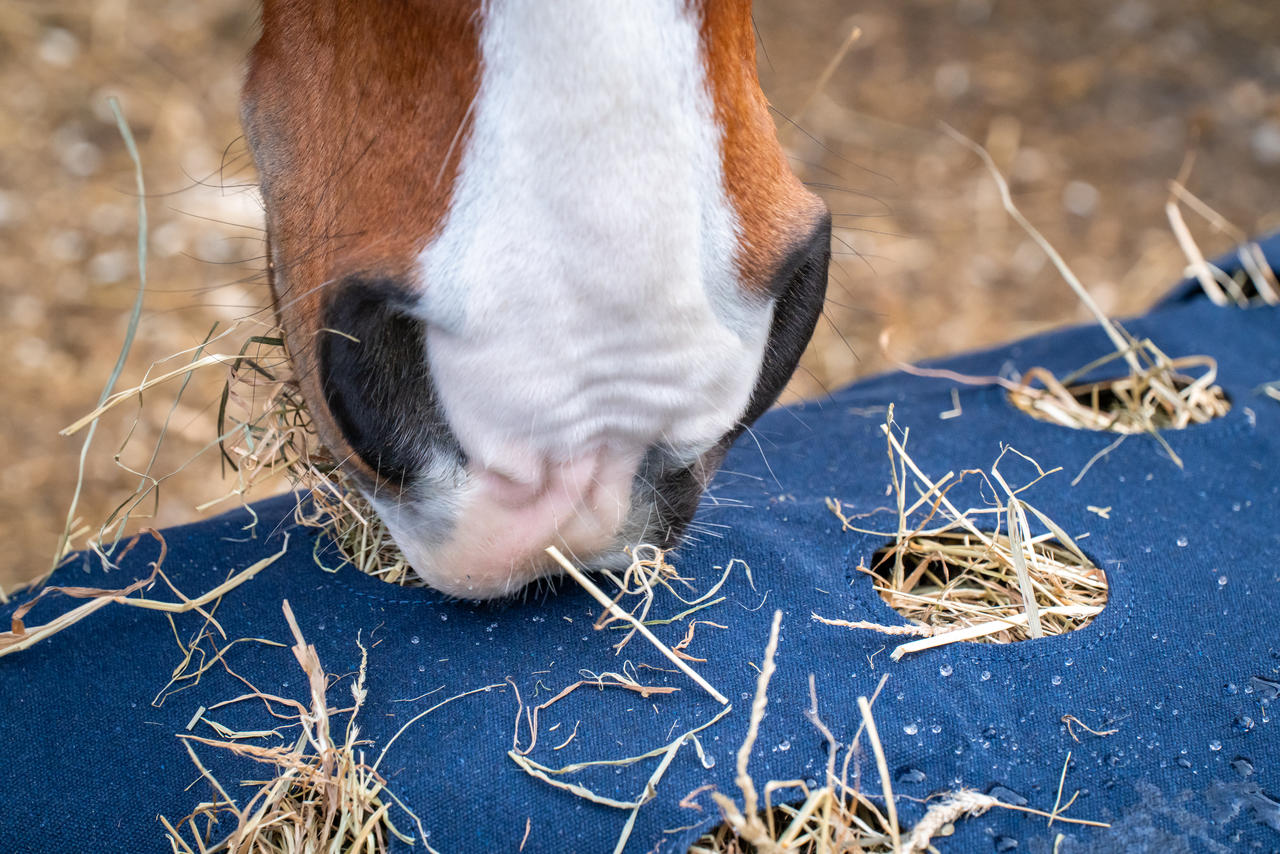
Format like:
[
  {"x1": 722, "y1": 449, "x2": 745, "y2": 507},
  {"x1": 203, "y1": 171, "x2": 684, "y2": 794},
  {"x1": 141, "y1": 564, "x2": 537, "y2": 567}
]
[{"x1": 859, "y1": 531, "x2": 1108, "y2": 643}]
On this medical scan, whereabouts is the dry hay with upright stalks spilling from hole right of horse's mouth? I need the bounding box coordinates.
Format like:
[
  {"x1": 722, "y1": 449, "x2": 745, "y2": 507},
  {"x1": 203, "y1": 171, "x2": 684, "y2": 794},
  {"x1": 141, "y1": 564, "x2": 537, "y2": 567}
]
[{"x1": 813, "y1": 407, "x2": 1107, "y2": 659}]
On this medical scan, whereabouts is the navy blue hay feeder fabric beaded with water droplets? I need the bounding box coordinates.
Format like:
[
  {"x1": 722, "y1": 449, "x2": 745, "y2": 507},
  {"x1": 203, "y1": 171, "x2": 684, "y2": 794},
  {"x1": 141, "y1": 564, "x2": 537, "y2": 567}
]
[{"x1": 0, "y1": 239, "x2": 1280, "y2": 854}]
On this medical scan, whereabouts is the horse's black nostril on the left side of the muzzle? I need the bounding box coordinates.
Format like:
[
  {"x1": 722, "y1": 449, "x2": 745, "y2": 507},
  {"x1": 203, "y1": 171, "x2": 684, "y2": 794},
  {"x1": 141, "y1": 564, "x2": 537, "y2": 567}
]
[{"x1": 316, "y1": 277, "x2": 461, "y2": 487}]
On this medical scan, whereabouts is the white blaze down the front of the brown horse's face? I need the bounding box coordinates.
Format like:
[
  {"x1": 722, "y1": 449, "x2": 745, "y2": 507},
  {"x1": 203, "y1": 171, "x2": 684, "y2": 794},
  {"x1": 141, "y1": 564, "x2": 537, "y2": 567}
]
[{"x1": 419, "y1": 0, "x2": 772, "y2": 481}]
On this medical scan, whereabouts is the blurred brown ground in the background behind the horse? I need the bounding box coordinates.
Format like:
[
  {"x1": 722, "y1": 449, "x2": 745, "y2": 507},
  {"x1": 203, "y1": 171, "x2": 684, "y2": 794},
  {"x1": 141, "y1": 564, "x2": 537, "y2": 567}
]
[{"x1": 0, "y1": 0, "x2": 1280, "y2": 585}]
